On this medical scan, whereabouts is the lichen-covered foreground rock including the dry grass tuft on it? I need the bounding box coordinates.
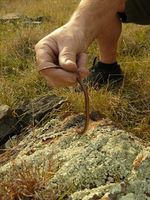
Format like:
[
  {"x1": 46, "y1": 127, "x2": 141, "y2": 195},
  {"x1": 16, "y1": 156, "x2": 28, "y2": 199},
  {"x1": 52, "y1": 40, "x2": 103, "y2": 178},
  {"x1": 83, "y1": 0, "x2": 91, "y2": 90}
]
[{"x1": 0, "y1": 117, "x2": 150, "y2": 200}]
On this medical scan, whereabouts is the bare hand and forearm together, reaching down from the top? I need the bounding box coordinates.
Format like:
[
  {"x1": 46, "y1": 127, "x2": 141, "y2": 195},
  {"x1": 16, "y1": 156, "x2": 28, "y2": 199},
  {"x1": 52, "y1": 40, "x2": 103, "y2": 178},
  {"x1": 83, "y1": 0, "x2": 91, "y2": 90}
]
[{"x1": 35, "y1": 0, "x2": 122, "y2": 87}]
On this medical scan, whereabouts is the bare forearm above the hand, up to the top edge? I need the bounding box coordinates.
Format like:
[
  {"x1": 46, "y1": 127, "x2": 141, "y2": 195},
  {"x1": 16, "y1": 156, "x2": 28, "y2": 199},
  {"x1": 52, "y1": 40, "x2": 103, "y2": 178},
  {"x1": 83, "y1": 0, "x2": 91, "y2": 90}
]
[{"x1": 69, "y1": 0, "x2": 124, "y2": 46}]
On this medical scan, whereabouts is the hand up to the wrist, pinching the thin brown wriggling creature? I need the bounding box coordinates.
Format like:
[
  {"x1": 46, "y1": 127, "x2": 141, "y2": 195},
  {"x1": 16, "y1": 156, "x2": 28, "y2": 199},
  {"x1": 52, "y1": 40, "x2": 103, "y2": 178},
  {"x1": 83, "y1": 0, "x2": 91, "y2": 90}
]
[{"x1": 35, "y1": 24, "x2": 89, "y2": 87}]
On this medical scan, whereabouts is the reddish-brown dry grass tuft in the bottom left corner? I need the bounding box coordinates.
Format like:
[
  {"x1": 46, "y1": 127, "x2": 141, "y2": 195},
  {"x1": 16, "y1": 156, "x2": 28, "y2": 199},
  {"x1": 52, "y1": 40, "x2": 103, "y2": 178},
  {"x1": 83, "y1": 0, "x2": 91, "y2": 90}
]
[{"x1": 0, "y1": 161, "x2": 54, "y2": 200}]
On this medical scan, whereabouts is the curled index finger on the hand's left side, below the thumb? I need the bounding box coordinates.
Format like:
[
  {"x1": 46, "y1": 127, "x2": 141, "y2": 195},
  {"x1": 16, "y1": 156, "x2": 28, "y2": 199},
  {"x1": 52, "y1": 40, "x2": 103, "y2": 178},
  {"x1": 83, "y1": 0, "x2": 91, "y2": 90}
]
[{"x1": 35, "y1": 37, "x2": 76, "y2": 87}]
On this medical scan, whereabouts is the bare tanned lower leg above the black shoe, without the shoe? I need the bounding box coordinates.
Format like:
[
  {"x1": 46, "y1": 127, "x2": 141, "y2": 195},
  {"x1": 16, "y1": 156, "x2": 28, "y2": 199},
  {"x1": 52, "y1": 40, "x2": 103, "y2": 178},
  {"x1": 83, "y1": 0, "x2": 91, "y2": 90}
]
[{"x1": 97, "y1": 3, "x2": 125, "y2": 64}]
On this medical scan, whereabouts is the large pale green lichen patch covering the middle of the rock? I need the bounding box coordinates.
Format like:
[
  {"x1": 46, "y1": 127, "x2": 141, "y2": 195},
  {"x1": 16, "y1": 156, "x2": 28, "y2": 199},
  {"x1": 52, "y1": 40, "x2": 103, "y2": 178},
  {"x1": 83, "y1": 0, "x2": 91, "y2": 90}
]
[{"x1": 46, "y1": 127, "x2": 141, "y2": 195}]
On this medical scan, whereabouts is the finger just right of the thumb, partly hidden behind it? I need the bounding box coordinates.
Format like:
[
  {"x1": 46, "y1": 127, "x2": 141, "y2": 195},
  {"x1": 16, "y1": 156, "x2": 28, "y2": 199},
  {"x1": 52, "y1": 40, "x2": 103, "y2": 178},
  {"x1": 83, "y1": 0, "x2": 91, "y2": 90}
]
[{"x1": 77, "y1": 53, "x2": 90, "y2": 79}]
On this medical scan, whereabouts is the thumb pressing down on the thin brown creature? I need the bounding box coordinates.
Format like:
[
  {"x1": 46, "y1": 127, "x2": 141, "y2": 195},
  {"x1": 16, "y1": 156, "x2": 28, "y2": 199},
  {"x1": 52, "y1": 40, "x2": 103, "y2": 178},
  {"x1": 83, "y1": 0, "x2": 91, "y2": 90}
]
[{"x1": 59, "y1": 46, "x2": 77, "y2": 72}]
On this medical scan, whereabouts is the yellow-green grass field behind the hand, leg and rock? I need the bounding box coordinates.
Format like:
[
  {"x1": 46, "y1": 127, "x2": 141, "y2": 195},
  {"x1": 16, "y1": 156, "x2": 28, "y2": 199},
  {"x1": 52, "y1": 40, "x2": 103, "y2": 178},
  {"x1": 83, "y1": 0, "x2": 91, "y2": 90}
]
[{"x1": 0, "y1": 0, "x2": 150, "y2": 141}]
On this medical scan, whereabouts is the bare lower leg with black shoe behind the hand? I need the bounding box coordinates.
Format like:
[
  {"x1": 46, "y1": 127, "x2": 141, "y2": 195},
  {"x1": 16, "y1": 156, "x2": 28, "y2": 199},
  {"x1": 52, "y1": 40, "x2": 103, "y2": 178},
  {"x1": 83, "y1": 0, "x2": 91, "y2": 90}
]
[{"x1": 89, "y1": 14, "x2": 123, "y2": 88}]
